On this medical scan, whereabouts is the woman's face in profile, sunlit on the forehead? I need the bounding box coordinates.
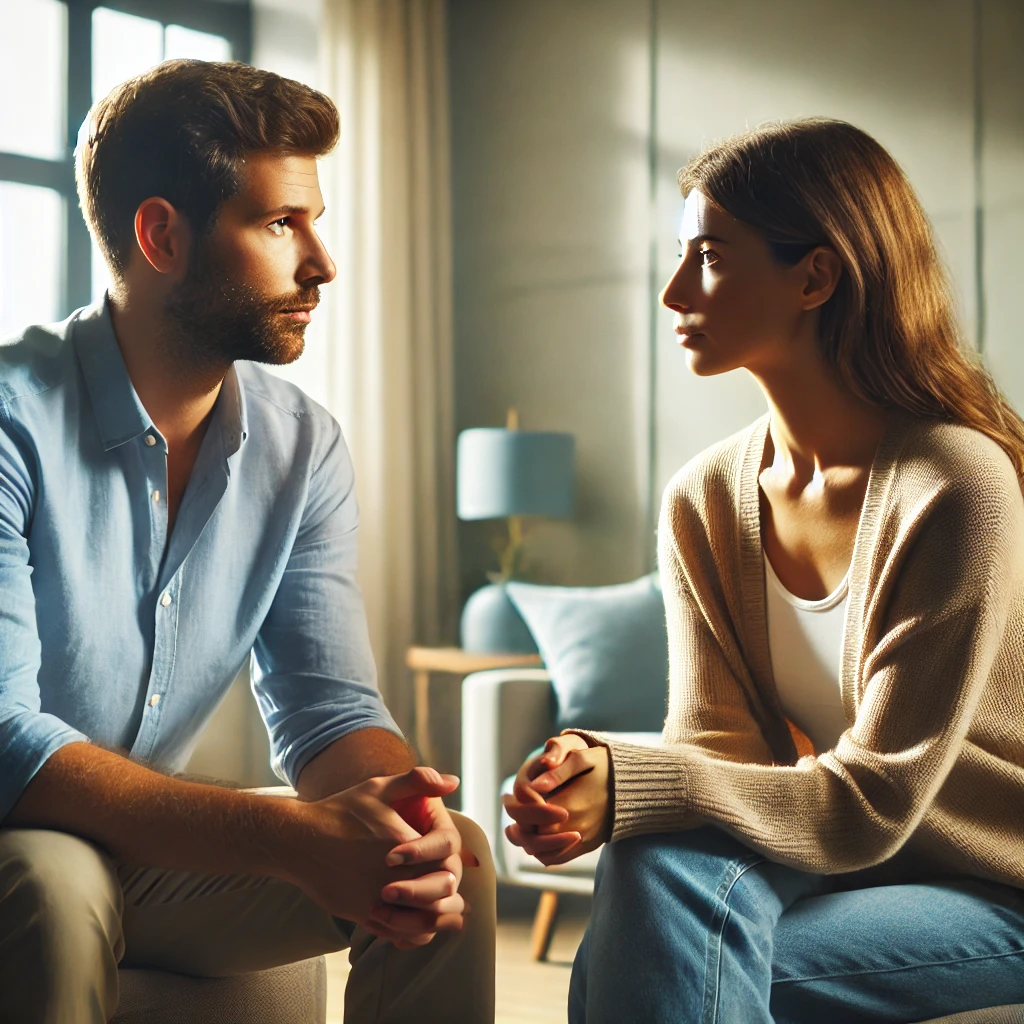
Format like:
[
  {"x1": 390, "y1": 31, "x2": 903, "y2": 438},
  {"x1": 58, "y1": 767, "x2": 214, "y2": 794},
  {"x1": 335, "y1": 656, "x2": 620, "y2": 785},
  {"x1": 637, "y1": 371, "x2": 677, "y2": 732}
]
[{"x1": 662, "y1": 191, "x2": 808, "y2": 377}]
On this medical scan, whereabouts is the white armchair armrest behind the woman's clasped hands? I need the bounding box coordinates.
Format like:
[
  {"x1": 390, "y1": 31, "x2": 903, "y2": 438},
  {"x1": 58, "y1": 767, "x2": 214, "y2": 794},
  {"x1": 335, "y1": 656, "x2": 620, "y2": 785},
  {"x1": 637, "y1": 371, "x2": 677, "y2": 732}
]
[{"x1": 462, "y1": 669, "x2": 555, "y2": 859}]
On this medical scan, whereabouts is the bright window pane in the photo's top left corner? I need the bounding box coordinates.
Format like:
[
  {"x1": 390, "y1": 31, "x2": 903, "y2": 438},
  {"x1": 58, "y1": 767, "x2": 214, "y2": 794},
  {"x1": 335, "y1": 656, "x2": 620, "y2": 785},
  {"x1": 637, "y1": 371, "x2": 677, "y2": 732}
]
[{"x1": 0, "y1": 0, "x2": 68, "y2": 160}]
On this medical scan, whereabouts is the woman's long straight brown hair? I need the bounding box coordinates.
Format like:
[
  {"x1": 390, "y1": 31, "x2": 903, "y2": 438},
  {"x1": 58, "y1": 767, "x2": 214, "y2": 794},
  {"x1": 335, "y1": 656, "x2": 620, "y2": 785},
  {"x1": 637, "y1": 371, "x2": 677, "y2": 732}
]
[{"x1": 679, "y1": 118, "x2": 1024, "y2": 478}]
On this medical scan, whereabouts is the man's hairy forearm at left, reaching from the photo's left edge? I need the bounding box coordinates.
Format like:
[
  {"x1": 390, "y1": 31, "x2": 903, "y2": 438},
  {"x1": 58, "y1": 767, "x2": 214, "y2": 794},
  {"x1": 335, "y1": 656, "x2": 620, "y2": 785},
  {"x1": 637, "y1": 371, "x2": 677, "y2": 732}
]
[{"x1": 2, "y1": 743, "x2": 303, "y2": 877}]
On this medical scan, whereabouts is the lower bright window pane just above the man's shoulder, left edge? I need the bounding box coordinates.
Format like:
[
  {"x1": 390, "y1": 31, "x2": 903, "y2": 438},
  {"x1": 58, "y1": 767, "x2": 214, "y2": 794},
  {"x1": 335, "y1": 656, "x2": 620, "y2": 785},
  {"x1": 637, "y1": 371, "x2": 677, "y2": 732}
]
[{"x1": 0, "y1": 181, "x2": 65, "y2": 338}]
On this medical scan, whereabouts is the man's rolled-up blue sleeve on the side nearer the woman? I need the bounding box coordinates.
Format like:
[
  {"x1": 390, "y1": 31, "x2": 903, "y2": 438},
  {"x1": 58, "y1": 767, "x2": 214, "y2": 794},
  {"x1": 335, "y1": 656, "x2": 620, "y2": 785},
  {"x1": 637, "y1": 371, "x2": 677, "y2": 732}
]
[{"x1": 253, "y1": 420, "x2": 401, "y2": 785}]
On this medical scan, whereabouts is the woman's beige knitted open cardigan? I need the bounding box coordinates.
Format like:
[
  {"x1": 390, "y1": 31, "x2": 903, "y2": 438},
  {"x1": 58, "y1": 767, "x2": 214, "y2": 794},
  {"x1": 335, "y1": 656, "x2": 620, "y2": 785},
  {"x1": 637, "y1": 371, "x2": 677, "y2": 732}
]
[{"x1": 590, "y1": 413, "x2": 1024, "y2": 887}]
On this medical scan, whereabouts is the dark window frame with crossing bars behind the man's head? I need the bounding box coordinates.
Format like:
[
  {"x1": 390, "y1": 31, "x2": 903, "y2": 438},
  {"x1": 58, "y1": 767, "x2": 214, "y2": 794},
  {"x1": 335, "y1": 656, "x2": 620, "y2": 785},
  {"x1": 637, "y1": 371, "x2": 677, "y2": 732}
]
[{"x1": 0, "y1": 0, "x2": 253, "y2": 316}]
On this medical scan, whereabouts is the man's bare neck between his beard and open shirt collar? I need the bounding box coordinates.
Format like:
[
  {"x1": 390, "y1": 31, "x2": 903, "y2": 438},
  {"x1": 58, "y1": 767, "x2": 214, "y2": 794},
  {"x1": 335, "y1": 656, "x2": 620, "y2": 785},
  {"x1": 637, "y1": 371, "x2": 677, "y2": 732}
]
[{"x1": 110, "y1": 296, "x2": 228, "y2": 449}]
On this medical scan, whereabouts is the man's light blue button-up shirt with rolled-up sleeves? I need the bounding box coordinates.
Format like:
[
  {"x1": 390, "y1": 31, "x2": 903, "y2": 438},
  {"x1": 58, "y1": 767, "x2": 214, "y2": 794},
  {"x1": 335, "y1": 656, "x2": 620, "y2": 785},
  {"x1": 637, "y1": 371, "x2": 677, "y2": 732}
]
[{"x1": 0, "y1": 305, "x2": 400, "y2": 819}]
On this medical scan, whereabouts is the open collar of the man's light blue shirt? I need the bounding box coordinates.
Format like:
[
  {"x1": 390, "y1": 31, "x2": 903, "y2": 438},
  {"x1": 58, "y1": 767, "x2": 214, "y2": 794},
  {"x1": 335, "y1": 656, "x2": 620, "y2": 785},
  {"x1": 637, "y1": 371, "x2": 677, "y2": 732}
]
[{"x1": 74, "y1": 299, "x2": 249, "y2": 457}]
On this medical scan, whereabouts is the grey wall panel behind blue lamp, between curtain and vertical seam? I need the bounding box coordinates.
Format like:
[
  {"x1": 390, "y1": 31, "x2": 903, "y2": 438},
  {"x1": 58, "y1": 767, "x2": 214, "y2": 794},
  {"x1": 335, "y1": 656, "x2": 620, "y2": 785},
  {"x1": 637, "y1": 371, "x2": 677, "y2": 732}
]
[{"x1": 449, "y1": 0, "x2": 650, "y2": 591}]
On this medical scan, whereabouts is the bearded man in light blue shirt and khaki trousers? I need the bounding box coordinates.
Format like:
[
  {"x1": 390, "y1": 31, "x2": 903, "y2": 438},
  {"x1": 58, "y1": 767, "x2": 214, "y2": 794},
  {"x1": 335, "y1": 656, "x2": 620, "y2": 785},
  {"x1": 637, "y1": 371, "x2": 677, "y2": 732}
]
[{"x1": 0, "y1": 60, "x2": 494, "y2": 1024}]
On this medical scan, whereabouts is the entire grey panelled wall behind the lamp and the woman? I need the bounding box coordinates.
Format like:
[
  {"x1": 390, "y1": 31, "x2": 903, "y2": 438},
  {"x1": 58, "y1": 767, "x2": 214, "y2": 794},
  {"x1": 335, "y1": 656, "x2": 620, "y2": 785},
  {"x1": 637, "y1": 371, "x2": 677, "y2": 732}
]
[{"x1": 449, "y1": 0, "x2": 1024, "y2": 589}]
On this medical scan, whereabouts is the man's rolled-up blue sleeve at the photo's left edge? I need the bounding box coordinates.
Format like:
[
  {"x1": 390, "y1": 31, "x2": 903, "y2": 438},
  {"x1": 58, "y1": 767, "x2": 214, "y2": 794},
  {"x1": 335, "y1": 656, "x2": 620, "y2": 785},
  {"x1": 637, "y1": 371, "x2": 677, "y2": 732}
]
[{"x1": 0, "y1": 403, "x2": 88, "y2": 821}]
